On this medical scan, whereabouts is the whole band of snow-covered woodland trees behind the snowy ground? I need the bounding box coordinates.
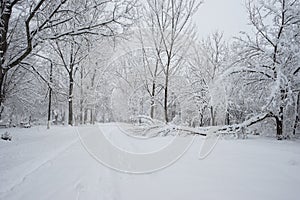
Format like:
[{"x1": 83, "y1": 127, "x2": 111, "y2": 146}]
[{"x1": 0, "y1": 0, "x2": 300, "y2": 139}]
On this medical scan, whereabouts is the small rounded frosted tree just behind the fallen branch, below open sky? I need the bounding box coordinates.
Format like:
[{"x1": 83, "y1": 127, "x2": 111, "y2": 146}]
[{"x1": 189, "y1": 31, "x2": 228, "y2": 126}]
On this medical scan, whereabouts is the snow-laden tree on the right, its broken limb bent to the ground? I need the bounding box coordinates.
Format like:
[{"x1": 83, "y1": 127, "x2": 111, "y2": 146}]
[{"x1": 230, "y1": 0, "x2": 300, "y2": 139}]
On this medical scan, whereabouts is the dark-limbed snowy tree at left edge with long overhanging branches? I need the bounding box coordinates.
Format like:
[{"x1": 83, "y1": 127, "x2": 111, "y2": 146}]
[{"x1": 0, "y1": 0, "x2": 136, "y2": 116}]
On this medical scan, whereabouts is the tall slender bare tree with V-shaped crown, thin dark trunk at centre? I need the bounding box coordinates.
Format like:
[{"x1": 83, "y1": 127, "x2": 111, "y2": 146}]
[{"x1": 147, "y1": 0, "x2": 202, "y2": 123}]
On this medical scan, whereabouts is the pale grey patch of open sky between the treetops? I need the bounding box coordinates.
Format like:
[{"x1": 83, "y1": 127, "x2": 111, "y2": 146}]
[{"x1": 194, "y1": 0, "x2": 250, "y2": 39}]
